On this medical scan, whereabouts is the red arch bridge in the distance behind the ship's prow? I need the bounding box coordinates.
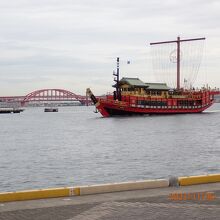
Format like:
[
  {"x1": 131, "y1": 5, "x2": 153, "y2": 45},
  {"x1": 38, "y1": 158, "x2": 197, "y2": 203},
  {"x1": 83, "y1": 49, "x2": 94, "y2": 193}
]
[{"x1": 0, "y1": 89, "x2": 91, "y2": 106}]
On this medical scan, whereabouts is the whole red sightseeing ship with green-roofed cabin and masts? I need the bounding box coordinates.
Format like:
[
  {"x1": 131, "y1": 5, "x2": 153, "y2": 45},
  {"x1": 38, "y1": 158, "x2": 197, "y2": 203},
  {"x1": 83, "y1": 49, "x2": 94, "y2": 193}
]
[{"x1": 87, "y1": 37, "x2": 215, "y2": 117}]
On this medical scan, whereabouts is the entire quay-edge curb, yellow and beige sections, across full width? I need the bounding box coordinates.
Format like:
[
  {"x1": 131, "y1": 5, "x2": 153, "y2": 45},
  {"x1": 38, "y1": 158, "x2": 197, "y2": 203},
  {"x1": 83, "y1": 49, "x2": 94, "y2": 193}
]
[{"x1": 0, "y1": 174, "x2": 220, "y2": 202}]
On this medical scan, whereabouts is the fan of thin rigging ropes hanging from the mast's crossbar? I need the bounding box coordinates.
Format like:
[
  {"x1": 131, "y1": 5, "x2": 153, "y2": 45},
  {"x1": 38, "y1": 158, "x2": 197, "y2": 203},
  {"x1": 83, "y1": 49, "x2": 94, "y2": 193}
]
[{"x1": 151, "y1": 40, "x2": 204, "y2": 89}]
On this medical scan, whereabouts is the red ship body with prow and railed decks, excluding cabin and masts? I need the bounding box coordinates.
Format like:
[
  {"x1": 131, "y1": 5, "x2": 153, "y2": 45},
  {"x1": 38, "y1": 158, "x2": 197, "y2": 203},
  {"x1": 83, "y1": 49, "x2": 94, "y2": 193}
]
[{"x1": 87, "y1": 86, "x2": 216, "y2": 117}]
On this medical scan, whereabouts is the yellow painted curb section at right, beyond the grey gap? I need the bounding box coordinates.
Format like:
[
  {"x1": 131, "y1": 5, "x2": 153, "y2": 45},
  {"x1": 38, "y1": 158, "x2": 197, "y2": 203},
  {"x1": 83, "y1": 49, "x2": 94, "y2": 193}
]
[{"x1": 178, "y1": 174, "x2": 220, "y2": 186}]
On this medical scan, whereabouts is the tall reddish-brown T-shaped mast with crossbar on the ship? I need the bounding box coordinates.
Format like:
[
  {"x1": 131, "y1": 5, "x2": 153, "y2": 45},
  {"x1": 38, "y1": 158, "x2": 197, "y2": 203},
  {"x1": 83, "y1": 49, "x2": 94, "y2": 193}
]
[{"x1": 150, "y1": 37, "x2": 205, "y2": 90}]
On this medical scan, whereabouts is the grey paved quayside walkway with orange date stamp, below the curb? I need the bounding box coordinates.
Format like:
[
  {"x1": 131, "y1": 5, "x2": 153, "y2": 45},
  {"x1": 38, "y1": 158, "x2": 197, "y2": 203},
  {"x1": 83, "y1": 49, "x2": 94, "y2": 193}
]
[{"x1": 0, "y1": 183, "x2": 220, "y2": 220}]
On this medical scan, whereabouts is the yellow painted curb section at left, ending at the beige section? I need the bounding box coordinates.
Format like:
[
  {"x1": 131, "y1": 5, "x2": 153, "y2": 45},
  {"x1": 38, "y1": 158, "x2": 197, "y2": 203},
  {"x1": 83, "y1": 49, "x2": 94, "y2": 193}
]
[{"x1": 0, "y1": 187, "x2": 80, "y2": 202}]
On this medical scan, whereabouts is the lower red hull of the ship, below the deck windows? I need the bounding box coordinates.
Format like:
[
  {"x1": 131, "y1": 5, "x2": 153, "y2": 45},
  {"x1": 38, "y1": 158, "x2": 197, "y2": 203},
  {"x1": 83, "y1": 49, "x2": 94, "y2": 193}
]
[{"x1": 96, "y1": 99, "x2": 213, "y2": 117}]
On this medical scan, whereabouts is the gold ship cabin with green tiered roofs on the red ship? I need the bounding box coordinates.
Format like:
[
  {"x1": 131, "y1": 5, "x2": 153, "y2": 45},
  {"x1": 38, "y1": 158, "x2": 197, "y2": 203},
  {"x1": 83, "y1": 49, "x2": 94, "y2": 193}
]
[{"x1": 113, "y1": 77, "x2": 170, "y2": 98}]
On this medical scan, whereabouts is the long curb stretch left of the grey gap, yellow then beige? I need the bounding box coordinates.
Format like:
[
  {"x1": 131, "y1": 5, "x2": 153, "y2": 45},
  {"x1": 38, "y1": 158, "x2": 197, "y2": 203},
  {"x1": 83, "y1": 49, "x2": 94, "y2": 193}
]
[{"x1": 0, "y1": 179, "x2": 169, "y2": 202}]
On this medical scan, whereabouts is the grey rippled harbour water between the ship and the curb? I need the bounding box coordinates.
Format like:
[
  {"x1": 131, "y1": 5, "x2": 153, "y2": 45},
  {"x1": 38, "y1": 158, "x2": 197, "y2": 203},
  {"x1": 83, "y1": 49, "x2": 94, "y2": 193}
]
[{"x1": 0, "y1": 104, "x2": 220, "y2": 191}]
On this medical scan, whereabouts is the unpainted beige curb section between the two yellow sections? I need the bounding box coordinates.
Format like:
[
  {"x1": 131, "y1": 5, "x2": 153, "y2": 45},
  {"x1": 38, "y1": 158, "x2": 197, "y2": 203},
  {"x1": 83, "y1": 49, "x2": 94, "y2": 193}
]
[{"x1": 80, "y1": 179, "x2": 169, "y2": 195}]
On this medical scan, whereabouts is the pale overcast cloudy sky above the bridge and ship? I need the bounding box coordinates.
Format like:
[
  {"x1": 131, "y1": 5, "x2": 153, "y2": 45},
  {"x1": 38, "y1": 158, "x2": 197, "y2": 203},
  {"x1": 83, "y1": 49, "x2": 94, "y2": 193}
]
[{"x1": 0, "y1": 0, "x2": 220, "y2": 96}]
